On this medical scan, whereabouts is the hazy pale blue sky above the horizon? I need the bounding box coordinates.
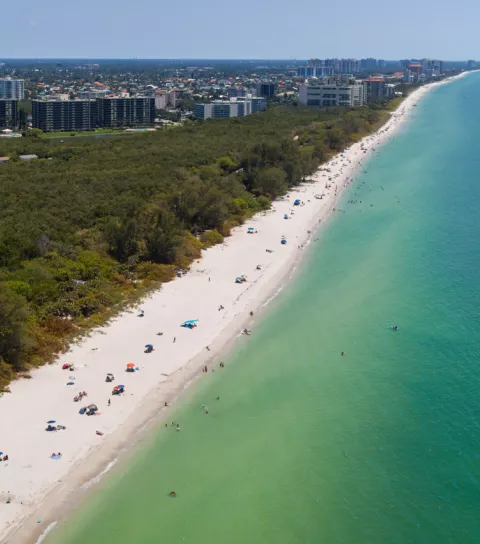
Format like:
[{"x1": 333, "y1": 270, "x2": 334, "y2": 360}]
[{"x1": 0, "y1": 0, "x2": 480, "y2": 60}]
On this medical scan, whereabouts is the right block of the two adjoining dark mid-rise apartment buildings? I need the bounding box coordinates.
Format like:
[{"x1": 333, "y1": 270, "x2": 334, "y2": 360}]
[{"x1": 96, "y1": 97, "x2": 155, "y2": 128}]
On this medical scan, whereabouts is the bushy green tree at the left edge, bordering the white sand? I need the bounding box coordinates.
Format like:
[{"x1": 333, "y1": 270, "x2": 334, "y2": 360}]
[{"x1": 0, "y1": 282, "x2": 32, "y2": 371}]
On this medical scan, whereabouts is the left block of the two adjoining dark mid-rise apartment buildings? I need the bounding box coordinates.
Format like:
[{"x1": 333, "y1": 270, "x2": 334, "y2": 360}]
[{"x1": 32, "y1": 100, "x2": 98, "y2": 132}]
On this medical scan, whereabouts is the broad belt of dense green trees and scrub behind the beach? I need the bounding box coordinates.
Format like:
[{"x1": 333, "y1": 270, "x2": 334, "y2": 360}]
[{"x1": 0, "y1": 100, "x2": 398, "y2": 386}]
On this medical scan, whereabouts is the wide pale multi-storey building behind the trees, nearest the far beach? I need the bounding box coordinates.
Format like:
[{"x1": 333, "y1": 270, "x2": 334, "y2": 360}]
[{"x1": 299, "y1": 77, "x2": 367, "y2": 108}]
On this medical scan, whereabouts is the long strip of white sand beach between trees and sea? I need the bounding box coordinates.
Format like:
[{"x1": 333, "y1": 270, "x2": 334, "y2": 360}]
[{"x1": 0, "y1": 72, "x2": 468, "y2": 543}]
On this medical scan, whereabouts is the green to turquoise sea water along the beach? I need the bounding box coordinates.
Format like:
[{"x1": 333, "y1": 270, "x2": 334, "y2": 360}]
[{"x1": 48, "y1": 74, "x2": 480, "y2": 544}]
